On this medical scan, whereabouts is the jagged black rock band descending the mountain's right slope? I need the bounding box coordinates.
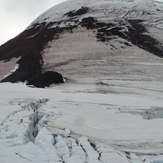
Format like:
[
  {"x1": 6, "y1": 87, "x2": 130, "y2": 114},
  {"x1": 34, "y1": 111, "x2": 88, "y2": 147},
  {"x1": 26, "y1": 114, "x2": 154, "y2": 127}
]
[{"x1": 81, "y1": 17, "x2": 163, "y2": 57}]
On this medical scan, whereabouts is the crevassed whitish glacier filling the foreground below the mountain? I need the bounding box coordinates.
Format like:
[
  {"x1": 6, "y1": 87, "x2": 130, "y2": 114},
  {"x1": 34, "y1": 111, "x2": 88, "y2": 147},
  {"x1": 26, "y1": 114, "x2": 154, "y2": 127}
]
[{"x1": 0, "y1": 80, "x2": 163, "y2": 163}]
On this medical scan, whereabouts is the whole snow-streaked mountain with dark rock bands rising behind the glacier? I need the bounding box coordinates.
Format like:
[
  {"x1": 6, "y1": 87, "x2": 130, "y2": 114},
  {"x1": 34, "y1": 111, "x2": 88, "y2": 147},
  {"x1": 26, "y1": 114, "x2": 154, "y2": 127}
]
[{"x1": 0, "y1": 0, "x2": 163, "y2": 82}]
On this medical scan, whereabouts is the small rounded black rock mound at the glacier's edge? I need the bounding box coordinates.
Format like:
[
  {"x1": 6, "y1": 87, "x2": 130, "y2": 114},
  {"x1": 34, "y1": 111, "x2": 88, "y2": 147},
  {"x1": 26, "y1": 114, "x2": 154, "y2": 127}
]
[{"x1": 27, "y1": 71, "x2": 64, "y2": 88}]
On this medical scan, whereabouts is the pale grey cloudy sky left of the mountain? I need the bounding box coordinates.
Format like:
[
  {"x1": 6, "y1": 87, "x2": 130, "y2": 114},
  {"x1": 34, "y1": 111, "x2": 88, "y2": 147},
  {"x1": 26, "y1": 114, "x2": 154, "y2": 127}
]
[{"x1": 0, "y1": 0, "x2": 65, "y2": 45}]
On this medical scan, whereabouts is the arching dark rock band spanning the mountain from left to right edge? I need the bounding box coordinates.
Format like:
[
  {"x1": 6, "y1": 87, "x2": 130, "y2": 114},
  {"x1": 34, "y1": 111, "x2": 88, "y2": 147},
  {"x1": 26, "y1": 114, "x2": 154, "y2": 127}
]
[{"x1": 0, "y1": 13, "x2": 163, "y2": 82}]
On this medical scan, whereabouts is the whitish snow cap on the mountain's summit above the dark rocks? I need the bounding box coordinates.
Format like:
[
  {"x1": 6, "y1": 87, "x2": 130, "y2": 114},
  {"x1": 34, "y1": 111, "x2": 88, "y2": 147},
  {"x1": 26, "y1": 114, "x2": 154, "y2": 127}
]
[{"x1": 29, "y1": 0, "x2": 163, "y2": 27}]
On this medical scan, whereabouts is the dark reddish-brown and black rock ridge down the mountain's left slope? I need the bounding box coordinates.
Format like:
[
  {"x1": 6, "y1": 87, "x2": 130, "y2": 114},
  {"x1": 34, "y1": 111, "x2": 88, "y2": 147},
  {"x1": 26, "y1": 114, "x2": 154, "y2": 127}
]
[{"x1": 0, "y1": 24, "x2": 68, "y2": 83}]
